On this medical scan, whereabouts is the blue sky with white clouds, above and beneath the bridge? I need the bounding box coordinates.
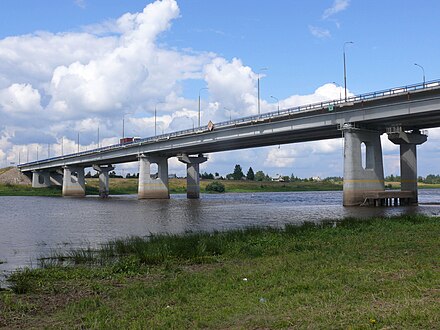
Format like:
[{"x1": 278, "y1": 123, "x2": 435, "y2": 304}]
[{"x1": 0, "y1": 0, "x2": 440, "y2": 178}]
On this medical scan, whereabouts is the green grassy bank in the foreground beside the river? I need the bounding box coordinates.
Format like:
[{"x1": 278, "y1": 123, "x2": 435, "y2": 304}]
[{"x1": 0, "y1": 216, "x2": 440, "y2": 329}]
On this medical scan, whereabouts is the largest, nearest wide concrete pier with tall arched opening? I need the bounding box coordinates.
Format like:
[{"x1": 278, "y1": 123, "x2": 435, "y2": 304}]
[{"x1": 343, "y1": 125, "x2": 385, "y2": 206}]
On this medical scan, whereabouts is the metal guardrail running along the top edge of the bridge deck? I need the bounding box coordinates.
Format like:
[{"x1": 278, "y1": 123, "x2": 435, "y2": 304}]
[{"x1": 17, "y1": 80, "x2": 440, "y2": 167}]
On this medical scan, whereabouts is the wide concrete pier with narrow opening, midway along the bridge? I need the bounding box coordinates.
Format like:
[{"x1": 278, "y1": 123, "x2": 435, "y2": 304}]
[{"x1": 138, "y1": 155, "x2": 170, "y2": 199}]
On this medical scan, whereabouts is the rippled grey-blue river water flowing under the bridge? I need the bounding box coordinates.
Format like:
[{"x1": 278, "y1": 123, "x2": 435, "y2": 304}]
[{"x1": 0, "y1": 189, "x2": 440, "y2": 284}]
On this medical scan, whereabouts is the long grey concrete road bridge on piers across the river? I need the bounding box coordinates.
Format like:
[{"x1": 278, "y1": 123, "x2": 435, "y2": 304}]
[{"x1": 18, "y1": 80, "x2": 440, "y2": 206}]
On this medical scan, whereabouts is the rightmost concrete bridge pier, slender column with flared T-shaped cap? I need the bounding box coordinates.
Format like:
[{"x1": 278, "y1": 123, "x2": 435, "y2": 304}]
[{"x1": 388, "y1": 131, "x2": 427, "y2": 205}]
